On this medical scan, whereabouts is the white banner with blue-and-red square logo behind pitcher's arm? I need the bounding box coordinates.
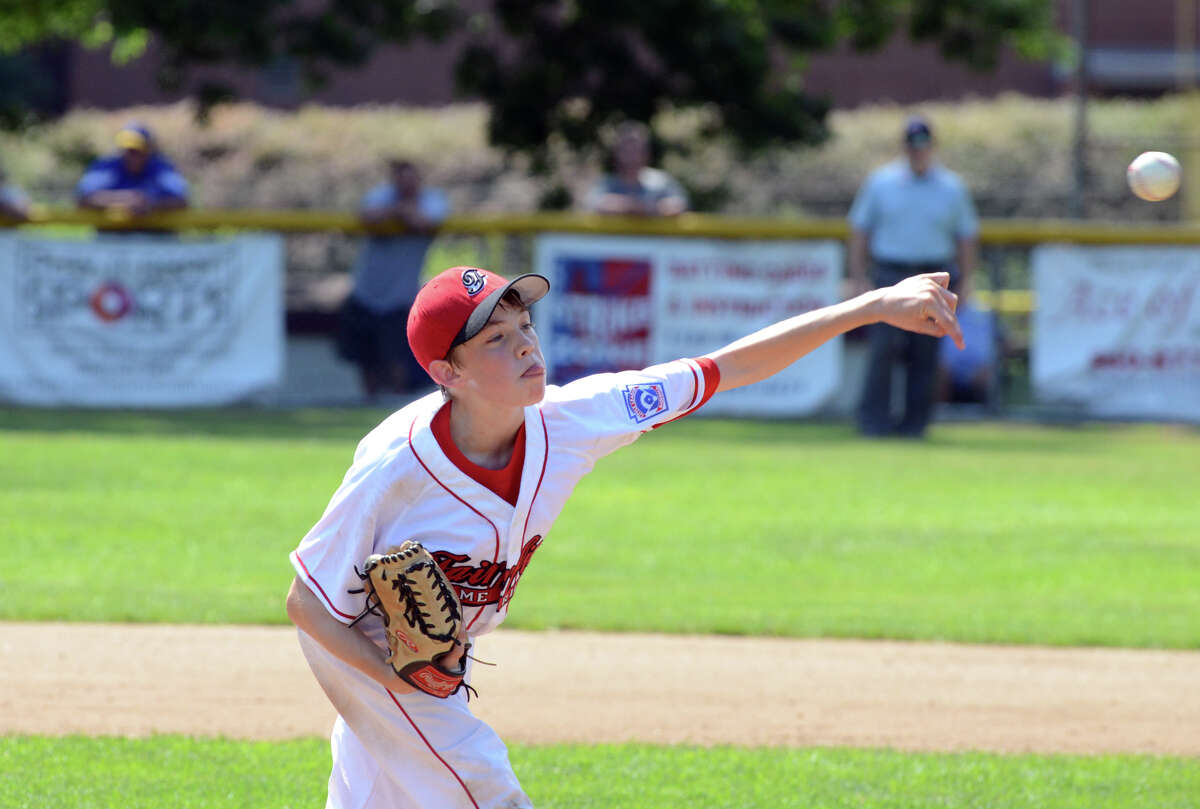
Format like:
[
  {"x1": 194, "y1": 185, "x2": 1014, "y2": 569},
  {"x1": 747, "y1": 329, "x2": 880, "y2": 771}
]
[{"x1": 534, "y1": 234, "x2": 842, "y2": 417}]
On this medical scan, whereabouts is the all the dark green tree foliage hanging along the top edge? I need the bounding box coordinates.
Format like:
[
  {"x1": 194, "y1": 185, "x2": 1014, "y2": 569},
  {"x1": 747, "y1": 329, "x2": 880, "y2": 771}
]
[{"x1": 0, "y1": 0, "x2": 1056, "y2": 156}]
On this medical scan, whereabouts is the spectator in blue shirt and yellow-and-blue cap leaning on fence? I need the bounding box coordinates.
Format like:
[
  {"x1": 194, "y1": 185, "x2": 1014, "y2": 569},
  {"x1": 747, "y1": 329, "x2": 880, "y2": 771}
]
[{"x1": 76, "y1": 124, "x2": 187, "y2": 216}]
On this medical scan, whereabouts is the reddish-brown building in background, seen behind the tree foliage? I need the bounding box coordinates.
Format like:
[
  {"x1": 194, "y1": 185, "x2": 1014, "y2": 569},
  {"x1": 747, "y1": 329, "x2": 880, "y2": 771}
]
[{"x1": 49, "y1": 0, "x2": 1198, "y2": 108}]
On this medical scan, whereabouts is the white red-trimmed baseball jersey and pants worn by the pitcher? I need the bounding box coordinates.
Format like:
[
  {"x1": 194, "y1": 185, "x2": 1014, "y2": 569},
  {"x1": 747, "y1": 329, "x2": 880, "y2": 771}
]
[{"x1": 290, "y1": 359, "x2": 720, "y2": 809}]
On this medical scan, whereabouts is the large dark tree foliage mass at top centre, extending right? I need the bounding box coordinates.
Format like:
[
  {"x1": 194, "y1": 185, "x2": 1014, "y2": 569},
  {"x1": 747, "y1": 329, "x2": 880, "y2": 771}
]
[{"x1": 458, "y1": 0, "x2": 1054, "y2": 157}]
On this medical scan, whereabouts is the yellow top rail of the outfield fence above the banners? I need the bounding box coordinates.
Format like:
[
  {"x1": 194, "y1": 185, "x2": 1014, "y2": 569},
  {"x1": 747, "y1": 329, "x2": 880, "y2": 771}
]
[{"x1": 11, "y1": 206, "x2": 1200, "y2": 316}]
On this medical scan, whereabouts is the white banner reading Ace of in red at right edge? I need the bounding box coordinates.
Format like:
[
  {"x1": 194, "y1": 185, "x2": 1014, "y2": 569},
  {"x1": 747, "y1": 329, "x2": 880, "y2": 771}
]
[{"x1": 1030, "y1": 245, "x2": 1200, "y2": 421}]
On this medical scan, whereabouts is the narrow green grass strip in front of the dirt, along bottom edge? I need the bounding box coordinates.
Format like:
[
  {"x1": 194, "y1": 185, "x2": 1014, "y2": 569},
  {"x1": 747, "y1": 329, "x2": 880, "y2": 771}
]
[{"x1": 0, "y1": 736, "x2": 1200, "y2": 809}]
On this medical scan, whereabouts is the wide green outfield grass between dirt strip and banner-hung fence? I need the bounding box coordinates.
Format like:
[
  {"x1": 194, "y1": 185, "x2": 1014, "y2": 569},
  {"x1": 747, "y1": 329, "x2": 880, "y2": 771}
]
[{"x1": 0, "y1": 411, "x2": 1200, "y2": 648}]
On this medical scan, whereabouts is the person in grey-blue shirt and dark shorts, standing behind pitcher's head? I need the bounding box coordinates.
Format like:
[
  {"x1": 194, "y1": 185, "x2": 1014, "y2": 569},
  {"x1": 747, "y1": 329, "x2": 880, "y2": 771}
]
[{"x1": 337, "y1": 160, "x2": 450, "y2": 398}]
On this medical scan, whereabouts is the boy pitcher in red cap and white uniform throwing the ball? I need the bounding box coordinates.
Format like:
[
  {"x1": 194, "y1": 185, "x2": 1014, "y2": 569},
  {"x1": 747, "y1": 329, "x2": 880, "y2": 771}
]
[{"x1": 287, "y1": 266, "x2": 962, "y2": 809}]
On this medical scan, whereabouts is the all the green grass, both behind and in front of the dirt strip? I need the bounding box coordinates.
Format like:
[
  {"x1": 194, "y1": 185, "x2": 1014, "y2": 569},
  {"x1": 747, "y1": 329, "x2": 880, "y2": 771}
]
[{"x1": 0, "y1": 409, "x2": 1200, "y2": 809}]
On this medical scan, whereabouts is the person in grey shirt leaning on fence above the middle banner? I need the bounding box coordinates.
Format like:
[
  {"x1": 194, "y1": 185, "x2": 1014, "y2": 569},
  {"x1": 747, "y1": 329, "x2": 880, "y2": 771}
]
[{"x1": 584, "y1": 121, "x2": 688, "y2": 216}]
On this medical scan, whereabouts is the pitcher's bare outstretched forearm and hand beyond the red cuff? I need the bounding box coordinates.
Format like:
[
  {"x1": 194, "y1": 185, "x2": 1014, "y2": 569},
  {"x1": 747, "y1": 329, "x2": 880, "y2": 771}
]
[{"x1": 708, "y1": 272, "x2": 962, "y2": 391}]
